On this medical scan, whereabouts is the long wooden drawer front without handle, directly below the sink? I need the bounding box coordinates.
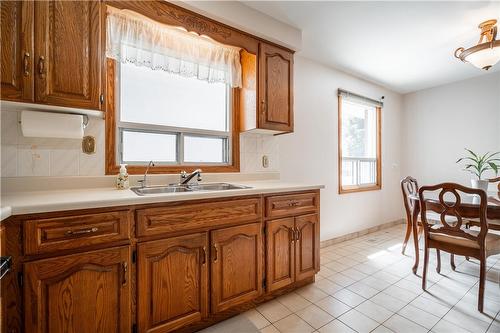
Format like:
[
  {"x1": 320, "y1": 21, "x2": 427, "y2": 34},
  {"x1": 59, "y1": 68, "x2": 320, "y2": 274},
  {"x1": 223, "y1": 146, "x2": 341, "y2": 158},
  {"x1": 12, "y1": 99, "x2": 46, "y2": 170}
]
[{"x1": 137, "y1": 198, "x2": 262, "y2": 237}]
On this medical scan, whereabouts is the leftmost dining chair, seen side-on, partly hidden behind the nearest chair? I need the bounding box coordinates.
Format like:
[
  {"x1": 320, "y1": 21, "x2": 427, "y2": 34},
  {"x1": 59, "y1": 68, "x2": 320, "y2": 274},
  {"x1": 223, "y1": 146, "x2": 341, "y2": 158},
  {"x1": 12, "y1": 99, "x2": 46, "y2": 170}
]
[{"x1": 401, "y1": 176, "x2": 441, "y2": 273}]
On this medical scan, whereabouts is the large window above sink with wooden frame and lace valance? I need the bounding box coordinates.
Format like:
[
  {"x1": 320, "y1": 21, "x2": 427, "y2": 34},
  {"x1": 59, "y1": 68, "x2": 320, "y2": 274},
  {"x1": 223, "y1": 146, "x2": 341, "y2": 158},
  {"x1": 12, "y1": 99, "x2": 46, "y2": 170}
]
[{"x1": 106, "y1": 7, "x2": 241, "y2": 173}]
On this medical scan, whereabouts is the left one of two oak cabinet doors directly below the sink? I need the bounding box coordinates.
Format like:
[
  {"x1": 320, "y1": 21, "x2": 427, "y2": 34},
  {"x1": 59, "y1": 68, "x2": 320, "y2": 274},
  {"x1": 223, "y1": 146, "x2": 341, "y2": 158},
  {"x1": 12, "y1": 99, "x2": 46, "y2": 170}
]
[{"x1": 137, "y1": 233, "x2": 208, "y2": 333}]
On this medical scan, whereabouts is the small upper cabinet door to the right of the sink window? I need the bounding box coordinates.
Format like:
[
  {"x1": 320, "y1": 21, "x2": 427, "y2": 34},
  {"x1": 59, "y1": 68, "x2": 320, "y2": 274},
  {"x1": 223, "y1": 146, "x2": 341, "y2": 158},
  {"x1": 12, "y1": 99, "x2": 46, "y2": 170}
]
[{"x1": 258, "y1": 43, "x2": 293, "y2": 132}]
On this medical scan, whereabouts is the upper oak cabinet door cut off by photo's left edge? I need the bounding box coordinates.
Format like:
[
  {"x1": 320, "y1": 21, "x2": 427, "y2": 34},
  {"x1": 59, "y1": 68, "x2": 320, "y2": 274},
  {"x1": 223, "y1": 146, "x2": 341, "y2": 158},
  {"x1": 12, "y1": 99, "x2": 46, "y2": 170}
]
[{"x1": 0, "y1": 1, "x2": 34, "y2": 102}]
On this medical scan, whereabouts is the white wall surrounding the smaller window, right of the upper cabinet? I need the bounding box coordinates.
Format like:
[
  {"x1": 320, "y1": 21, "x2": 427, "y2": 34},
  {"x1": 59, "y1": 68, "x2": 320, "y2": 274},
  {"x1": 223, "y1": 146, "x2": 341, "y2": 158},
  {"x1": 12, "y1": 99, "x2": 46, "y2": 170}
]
[{"x1": 279, "y1": 56, "x2": 402, "y2": 240}]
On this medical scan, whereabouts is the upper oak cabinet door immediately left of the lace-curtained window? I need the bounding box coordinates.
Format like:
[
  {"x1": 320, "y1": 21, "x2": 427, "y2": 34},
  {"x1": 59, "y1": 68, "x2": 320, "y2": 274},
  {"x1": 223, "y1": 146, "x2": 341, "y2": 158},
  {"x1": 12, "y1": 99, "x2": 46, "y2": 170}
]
[{"x1": 34, "y1": 0, "x2": 101, "y2": 109}]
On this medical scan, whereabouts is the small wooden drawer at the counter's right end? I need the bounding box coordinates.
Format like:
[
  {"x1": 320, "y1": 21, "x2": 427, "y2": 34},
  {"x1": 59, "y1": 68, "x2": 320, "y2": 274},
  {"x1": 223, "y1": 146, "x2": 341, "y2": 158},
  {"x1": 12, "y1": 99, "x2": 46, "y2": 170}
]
[{"x1": 266, "y1": 192, "x2": 319, "y2": 218}]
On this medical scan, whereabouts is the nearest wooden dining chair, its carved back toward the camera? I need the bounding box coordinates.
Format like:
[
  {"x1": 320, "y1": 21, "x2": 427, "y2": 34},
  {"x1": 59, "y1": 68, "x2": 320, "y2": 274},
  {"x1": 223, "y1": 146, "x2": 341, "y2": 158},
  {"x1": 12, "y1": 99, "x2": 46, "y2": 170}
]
[{"x1": 419, "y1": 183, "x2": 500, "y2": 312}]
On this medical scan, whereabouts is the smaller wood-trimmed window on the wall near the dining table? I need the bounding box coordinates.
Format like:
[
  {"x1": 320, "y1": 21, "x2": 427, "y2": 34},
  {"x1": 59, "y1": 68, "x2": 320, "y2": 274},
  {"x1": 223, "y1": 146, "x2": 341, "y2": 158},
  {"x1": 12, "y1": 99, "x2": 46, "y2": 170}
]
[{"x1": 338, "y1": 90, "x2": 383, "y2": 194}]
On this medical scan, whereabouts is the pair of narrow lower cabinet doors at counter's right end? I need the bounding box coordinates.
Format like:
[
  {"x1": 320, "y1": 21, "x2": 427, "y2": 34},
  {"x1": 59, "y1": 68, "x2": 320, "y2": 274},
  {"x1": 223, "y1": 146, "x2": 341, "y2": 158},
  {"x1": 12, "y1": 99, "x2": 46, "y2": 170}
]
[{"x1": 266, "y1": 214, "x2": 319, "y2": 292}]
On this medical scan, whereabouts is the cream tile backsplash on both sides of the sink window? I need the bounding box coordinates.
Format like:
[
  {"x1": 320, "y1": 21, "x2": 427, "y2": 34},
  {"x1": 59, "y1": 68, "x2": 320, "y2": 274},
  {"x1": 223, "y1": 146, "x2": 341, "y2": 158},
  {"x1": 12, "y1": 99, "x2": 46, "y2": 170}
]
[{"x1": 0, "y1": 110, "x2": 279, "y2": 177}]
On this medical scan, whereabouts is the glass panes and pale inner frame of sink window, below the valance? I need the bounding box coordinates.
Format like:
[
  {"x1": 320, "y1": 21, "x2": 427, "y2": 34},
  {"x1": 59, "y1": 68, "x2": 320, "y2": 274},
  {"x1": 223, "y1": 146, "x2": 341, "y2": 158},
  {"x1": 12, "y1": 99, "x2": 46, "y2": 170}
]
[{"x1": 116, "y1": 63, "x2": 232, "y2": 166}]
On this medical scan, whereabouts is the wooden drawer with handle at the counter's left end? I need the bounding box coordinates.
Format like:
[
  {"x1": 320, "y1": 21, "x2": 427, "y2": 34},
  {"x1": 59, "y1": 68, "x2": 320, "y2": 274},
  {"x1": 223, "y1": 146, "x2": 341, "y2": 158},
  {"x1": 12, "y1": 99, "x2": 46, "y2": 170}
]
[{"x1": 24, "y1": 211, "x2": 131, "y2": 254}]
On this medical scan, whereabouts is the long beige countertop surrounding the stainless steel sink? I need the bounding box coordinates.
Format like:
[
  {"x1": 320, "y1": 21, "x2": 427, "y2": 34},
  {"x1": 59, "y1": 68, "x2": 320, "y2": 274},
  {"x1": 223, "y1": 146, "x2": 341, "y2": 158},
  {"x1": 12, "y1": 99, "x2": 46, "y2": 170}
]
[{"x1": 0, "y1": 180, "x2": 324, "y2": 220}]
